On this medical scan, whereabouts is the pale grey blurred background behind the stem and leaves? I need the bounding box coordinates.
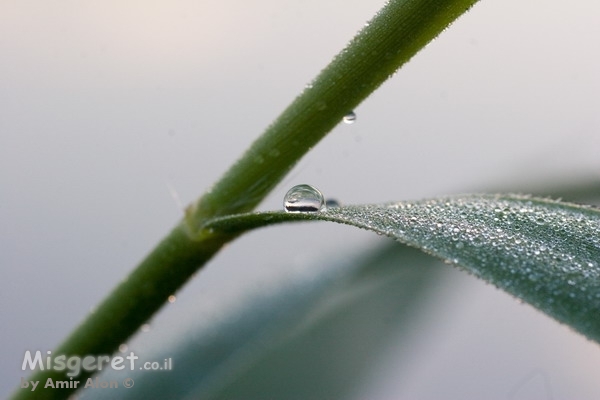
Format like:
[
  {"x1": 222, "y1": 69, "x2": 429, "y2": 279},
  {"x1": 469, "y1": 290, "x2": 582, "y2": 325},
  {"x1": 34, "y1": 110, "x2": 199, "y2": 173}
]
[{"x1": 0, "y1": 0, "x2": 600, "y2": 400}]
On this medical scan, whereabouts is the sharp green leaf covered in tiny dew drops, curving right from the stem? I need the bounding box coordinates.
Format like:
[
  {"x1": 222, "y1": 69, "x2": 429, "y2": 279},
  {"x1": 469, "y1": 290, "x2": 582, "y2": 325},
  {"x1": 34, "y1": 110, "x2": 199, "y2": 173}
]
[{"x1": 205, "y1": 195, "x2": 600, "y2": 342}]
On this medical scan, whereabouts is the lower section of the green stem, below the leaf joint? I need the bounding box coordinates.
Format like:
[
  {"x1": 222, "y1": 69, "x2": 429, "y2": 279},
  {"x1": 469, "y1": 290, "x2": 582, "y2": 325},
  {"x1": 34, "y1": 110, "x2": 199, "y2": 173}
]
[{"x1": 15, "y1": 224, "x2": 235, "y2": 399}]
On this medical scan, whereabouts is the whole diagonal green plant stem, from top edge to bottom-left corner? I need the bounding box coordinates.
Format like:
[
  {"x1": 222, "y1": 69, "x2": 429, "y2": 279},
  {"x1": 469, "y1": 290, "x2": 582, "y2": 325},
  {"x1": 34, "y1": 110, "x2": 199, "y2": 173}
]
[{"x1": 15, "y1": 0, "x2": 476, "y2": 399}]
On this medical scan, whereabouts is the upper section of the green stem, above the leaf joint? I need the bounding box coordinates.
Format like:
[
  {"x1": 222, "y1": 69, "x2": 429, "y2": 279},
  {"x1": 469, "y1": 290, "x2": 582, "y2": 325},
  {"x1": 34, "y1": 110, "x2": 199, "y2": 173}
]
[{"x1": 190, "y1": 0, "x2": 476, "y2": 225}]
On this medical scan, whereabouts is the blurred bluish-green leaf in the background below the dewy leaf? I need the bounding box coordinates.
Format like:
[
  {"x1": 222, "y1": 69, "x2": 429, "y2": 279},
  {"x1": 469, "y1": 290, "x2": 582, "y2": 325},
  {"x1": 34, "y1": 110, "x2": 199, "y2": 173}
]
[{"x1": 81, "y1": 245, "x2": 447, "y2": 399}]
